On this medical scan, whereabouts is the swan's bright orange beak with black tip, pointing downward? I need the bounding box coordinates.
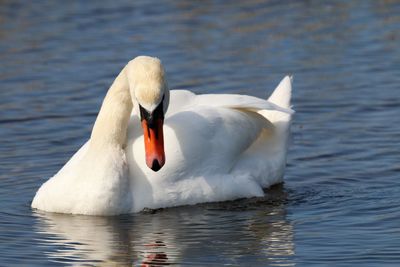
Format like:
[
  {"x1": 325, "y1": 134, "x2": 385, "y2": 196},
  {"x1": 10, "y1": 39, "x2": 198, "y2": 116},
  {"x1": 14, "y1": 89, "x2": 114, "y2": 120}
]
[{"x1": 142, "y1": 118, "x2": 165, "y2": 172}]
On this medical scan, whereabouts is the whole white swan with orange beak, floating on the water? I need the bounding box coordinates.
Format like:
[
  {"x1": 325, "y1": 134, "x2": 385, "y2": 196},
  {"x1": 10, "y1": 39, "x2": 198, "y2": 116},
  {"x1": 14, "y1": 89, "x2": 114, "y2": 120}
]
[{"x1": 32, "y1": 56, "x2": 293, "y2": 215}]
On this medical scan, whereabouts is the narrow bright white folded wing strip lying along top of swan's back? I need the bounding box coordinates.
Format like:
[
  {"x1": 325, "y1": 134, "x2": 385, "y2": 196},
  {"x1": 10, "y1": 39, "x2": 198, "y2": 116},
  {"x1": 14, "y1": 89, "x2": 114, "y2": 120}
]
[{"x1": 196, "y1": 94, "x2": 293, "y2": 114}]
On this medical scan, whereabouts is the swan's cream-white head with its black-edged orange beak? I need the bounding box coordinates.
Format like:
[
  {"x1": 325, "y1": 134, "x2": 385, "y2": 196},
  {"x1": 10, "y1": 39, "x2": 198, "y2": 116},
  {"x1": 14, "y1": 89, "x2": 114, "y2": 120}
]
[{"x1": 126, "y1": 56, "x2": 169, "y2": 171}]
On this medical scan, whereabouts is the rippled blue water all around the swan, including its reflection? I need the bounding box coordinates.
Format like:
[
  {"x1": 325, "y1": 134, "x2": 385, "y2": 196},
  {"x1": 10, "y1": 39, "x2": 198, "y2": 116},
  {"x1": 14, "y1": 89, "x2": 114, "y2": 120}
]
[{"x1": 0, "y1": 0, "x2": 400, "y2": 266}]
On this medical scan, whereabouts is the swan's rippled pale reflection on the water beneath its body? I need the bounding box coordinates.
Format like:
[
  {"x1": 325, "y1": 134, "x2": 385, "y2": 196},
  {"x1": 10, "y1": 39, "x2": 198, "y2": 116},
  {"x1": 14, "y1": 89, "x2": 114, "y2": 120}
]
[{"x1": 35, "y1": 186, "x2": 294, "y2": 266}]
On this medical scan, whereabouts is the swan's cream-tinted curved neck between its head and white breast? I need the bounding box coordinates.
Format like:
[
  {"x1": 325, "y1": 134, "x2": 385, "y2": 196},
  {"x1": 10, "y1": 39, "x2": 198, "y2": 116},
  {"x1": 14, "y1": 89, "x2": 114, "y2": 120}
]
[{"x1": 90, "y1": 67, "x2": 132, "y2": 150}]
